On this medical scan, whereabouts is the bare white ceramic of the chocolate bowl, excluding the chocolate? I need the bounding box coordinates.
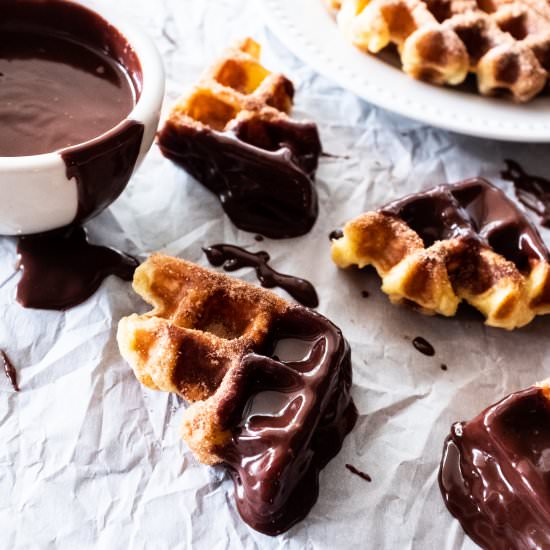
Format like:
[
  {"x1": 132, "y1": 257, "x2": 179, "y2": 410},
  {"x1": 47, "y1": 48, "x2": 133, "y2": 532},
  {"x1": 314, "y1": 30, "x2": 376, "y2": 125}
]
[{"x1": 0, "y1": 0, "x2": 164, "y2": 235}]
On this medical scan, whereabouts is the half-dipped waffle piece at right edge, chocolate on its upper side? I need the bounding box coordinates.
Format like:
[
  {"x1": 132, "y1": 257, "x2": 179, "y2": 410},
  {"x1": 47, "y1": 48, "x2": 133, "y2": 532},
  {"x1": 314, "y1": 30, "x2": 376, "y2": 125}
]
[{"x1": 332, "y1": 178, "x2": 550, "y2": 329}]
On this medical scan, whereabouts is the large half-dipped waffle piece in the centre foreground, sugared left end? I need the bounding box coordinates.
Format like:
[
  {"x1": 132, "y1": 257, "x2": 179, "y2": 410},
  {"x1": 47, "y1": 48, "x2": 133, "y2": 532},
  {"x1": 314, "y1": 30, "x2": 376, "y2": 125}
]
[{"x1": 117, "y1": 255, "x2": 357, "y2": 535}]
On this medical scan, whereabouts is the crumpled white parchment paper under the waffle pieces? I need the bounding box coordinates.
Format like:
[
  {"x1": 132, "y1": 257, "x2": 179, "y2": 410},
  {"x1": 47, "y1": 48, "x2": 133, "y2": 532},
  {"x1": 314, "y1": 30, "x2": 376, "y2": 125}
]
[{"x1": 0, "y1": 0, "x2": 550, "y2": 549}]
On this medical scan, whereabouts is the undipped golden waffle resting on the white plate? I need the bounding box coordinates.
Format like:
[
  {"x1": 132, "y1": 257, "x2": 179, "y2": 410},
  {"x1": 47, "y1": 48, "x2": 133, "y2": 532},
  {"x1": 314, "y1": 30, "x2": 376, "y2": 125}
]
[{"x1": 333, "y1": 0, "x2": 550, "y2": 102}]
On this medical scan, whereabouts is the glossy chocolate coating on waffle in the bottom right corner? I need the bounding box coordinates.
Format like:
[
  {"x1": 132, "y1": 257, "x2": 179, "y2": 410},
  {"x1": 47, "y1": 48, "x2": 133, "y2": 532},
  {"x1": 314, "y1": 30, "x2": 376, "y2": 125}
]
[{"x1": 439, "y1": 387, "x2": 550, "y2": 550}]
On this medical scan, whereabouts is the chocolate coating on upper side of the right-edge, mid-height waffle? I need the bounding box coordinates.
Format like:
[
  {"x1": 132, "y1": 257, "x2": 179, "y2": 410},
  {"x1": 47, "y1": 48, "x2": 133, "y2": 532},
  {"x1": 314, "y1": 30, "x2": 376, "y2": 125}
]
[{"x1": 380, "y1": 178, "x2": 550, "y2": 271}]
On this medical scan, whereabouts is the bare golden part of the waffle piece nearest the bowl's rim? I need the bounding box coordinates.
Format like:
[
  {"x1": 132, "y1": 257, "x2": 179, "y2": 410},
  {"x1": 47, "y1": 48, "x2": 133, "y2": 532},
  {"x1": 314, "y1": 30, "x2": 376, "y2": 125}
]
[{"x1": 164, "y1": 38, "x2": 294, "y2": 135}]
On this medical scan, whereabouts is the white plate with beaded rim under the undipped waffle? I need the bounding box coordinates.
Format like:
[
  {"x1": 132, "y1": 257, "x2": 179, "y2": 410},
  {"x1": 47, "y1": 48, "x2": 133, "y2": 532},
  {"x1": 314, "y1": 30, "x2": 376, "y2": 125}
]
[{"x1": 261, "y1": 0, "x2": 550, "y2": 142}]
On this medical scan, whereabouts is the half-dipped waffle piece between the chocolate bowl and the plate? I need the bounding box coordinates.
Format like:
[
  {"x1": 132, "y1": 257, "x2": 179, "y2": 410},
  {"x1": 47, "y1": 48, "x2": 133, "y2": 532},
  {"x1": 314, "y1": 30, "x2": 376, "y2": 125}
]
[{"x1": 158, "y1": 38, "x2": 321, "y2": 238}]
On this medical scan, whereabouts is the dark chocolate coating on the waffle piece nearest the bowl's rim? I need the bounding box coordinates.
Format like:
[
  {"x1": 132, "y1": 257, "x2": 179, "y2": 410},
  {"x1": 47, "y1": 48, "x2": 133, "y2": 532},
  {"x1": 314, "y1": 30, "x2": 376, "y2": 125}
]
[{"x1": 158, "y1": 119, "x2": 321, "y2": 239}]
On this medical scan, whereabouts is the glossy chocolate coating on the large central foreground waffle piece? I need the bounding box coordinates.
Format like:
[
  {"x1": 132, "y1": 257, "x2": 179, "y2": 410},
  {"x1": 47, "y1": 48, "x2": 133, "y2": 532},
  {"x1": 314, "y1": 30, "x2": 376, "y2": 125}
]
[{"x1": 213, "y1": 306, "x2": 357, "y2": 535}]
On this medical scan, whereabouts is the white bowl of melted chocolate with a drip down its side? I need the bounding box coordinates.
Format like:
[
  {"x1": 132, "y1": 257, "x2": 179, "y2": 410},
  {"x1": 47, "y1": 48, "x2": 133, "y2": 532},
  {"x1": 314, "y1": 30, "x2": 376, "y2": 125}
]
[{"x1": 0, "y1": 0, "x2": 164, "y2": 235}]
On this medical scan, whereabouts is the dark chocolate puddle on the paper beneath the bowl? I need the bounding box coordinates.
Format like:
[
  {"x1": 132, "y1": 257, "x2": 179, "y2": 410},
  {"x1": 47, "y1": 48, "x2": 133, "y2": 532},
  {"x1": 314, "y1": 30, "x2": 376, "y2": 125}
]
[{"x1": 17, "y1": 226, "x2": 138, "y2": 310}]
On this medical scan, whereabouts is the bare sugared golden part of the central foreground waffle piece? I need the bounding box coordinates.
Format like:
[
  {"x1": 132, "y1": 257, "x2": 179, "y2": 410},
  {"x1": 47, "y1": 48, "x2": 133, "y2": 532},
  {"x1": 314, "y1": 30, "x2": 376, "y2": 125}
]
[{"x1": 118, "y1": 254, "x2": 291, "y2": 464}]
